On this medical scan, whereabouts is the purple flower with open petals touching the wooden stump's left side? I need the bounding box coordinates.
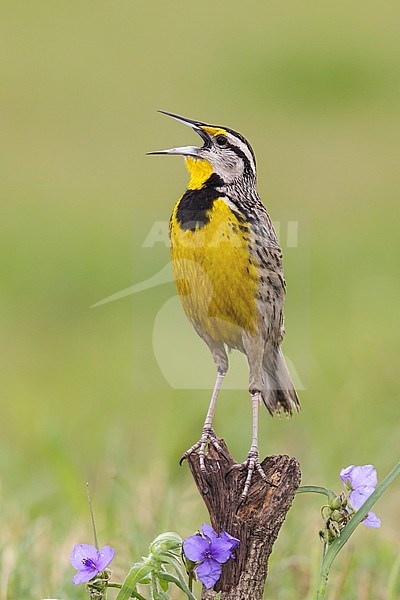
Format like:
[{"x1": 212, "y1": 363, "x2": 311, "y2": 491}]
[{"x1": 183, "y1": 523, "x2": 240, "y2": 589}]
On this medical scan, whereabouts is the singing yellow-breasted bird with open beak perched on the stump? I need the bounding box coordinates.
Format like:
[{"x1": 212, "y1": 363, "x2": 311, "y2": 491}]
[{"x1": 148, "y1": 110, "x2": 300, "y2": 502}]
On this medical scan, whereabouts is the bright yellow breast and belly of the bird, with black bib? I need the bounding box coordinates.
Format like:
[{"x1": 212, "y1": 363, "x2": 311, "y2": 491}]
[{"x1": 171, "y1": 195, "x2": 259, "y2": 347}]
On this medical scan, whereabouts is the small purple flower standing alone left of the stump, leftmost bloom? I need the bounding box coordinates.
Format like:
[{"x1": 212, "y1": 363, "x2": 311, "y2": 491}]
[{"x1": 70, "y1": 544, "x2": 114, "y2": 585}]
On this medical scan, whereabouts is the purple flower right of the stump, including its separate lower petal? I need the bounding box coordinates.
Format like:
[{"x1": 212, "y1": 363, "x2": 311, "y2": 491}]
[{"x1": 340, "y1": 465, "x2": 381, "y2": 528}]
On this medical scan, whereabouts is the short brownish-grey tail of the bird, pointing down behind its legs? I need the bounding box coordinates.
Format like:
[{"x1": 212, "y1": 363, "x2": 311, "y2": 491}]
[{"x1": 262, "y1": 348, "x2": 300, "y2": 415}]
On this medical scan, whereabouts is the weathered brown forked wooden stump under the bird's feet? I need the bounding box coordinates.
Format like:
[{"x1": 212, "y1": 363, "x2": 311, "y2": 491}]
[{"x1": 188, "y1": 439, "x2": 301, "y2": 600}]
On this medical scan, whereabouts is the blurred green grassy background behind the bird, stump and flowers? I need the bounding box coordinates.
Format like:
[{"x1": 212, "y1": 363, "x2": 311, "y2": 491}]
[{"x1": 0, "y1": 0, "x2": 400, "y2": 600}]
